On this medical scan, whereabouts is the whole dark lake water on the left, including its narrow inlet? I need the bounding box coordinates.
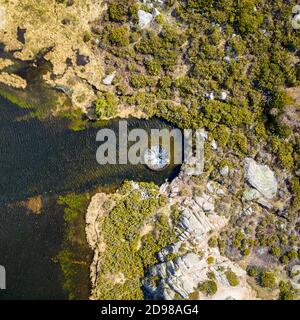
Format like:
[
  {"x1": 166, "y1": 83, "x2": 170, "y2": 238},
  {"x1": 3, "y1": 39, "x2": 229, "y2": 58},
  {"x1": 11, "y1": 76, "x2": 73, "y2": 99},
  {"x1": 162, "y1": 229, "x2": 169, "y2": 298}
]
[{"x1": 0, "y1": 97, "x2": 179, "y2": 299}]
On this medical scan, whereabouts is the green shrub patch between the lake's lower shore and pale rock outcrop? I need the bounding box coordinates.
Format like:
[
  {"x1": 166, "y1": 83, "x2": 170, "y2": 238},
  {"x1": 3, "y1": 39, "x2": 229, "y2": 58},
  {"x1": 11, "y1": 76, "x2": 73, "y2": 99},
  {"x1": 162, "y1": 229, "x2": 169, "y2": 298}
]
[{"x1": 96, "y1": 182, "x2": 176, "y2": 300}]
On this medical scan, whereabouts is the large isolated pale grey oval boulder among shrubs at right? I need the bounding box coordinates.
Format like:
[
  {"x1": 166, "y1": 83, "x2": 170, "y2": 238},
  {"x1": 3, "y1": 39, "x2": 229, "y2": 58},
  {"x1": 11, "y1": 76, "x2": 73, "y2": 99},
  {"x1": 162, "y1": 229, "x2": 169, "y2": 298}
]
[{"x1": 245, "y1": 158, "x2": 277, "y2": 199}]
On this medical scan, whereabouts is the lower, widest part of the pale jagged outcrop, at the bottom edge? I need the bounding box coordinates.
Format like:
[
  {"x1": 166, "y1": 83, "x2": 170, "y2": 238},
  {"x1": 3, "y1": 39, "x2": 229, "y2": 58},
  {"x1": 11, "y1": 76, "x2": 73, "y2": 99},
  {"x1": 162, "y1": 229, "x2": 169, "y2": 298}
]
[{"x1": 144, "y1": 249, "x2": 255, "y2": 300}]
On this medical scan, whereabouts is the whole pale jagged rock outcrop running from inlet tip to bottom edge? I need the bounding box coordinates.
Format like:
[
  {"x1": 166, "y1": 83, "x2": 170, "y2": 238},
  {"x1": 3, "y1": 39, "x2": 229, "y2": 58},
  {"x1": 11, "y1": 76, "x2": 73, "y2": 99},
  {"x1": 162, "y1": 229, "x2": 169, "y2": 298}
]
[{"x1": 144, "y1": 158, "x2": 254, "y2": 299}]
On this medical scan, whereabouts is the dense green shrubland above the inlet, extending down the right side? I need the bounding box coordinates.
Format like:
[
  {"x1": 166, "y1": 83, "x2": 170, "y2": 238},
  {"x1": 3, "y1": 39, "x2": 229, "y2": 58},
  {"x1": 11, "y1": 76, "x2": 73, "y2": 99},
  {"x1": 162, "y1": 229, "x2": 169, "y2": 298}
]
[{"x1": 89, "y1": 0, "x2": 300, "y2": 300}]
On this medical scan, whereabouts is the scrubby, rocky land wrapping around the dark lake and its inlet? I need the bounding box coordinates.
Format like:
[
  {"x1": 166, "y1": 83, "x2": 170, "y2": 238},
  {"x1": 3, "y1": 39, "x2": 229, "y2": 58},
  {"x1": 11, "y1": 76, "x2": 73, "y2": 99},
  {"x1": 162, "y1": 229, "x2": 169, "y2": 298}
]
[{"x1": 0, "y1": 0, "x2": 300, "y2": 299}]
